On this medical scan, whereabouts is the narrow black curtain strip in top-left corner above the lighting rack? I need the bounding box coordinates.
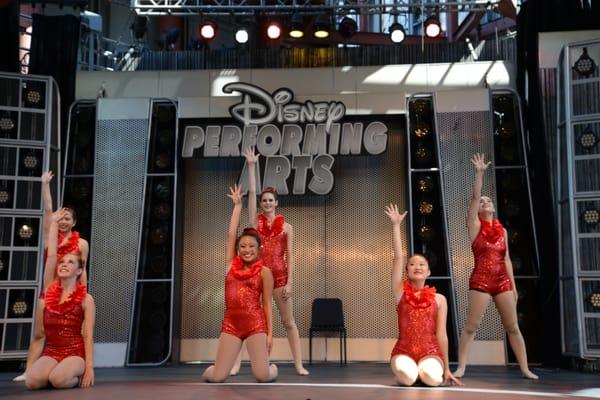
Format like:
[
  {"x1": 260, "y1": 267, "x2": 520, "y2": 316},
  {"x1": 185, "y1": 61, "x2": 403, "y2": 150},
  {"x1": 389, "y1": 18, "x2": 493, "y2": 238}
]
[{"x1": 0, "y1": 0, "x2": 20, "y2": 72}]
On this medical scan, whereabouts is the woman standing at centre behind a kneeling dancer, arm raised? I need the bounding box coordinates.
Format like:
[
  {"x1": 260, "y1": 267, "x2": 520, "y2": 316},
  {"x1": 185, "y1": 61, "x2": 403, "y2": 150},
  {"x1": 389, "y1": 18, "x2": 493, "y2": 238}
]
[{"x1": 231, "y1": 148, "x2": 308, "y2": 375}]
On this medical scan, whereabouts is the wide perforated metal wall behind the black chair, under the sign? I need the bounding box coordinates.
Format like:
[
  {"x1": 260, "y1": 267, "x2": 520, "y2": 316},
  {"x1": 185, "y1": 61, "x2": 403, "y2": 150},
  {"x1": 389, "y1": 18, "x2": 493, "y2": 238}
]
[{"x1": 181, "y1": 117, "x2": 406, "y2": 339}]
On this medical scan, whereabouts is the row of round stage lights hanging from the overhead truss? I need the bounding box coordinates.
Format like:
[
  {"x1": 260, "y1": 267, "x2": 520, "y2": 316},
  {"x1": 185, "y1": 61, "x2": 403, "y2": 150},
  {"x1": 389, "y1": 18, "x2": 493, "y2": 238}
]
[{"x1": 198, "y1": 14, "x2": 442, "y2": 44}]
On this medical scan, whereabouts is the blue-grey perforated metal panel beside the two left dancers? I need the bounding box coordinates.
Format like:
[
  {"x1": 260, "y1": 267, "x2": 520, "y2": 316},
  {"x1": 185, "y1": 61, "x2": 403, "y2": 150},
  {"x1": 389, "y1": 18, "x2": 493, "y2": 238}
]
[{"x1": 90, "y1": 119, "x2": 148, "y2": 343}]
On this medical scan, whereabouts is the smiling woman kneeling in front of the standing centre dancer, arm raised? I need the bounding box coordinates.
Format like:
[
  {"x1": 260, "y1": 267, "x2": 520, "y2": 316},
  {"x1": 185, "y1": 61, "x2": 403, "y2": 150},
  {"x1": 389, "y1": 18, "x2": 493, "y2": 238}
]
[{"x1": 202, "y1": 185, "x2": 277, "y2": 382}]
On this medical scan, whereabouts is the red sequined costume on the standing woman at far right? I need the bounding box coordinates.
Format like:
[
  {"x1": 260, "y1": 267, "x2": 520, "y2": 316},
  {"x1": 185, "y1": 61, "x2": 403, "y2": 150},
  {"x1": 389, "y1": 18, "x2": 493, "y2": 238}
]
[{"x1": 469, "y1": 218, "x2": 512, "y2": 296}]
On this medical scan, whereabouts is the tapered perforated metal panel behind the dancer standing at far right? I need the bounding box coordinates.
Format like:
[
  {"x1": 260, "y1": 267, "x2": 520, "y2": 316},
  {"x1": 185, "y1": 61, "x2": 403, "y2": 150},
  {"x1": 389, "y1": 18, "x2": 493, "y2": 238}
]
[{"x1": 437, "y1": 111, "x2": 504, "y2": 340}]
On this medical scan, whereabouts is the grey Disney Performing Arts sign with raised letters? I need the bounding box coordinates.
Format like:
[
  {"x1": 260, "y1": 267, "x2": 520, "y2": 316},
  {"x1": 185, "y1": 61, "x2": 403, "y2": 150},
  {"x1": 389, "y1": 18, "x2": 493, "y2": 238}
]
[{"x1": 181, "y1": 82, "x2": 388, "y2": 195}]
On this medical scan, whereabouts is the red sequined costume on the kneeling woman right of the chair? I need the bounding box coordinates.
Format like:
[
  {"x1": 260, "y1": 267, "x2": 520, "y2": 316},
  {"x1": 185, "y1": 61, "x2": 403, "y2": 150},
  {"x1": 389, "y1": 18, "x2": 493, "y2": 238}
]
[{"x1": 390, "y1": 281, "x2": 443, "y2": 363}]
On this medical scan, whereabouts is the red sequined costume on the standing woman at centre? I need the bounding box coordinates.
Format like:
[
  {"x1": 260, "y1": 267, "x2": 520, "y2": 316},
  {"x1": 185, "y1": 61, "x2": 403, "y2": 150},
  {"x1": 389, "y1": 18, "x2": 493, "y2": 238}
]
[{"x1": 257, "y1": 214, "x2": 287, "y2": 289}]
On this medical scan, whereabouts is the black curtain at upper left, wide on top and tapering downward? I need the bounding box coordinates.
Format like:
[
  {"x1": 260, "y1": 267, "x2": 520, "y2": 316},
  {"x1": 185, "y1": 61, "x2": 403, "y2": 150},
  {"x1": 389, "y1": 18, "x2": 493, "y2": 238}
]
[{"x1": 29, "y1": 14, "x2": 80, "y2": 158}]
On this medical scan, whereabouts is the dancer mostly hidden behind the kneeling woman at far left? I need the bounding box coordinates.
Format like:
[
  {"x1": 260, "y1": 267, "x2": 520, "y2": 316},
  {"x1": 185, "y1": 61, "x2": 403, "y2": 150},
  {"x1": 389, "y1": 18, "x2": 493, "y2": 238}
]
[{"x1": 13, "y1": 171, "x2": 89, "y2": 382}]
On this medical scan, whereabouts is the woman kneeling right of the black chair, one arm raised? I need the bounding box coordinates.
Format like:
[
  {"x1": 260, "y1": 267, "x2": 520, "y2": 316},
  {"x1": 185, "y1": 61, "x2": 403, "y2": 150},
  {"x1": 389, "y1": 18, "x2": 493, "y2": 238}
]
[{"x1": 385, "y1": 204, "x2": 462, "y2": 386}]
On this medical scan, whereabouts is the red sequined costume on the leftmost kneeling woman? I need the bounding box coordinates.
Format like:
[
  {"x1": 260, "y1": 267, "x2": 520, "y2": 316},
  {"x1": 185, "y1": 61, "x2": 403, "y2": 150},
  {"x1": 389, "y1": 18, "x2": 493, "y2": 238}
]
[{"x1": 42, "y1": 283, "x2": 87, "y2": 362}]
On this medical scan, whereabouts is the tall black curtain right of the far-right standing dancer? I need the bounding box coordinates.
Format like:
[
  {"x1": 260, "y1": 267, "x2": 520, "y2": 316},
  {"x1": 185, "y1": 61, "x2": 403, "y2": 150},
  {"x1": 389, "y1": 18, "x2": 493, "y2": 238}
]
[{"x1": 517, "y1": 0, "x2": 600, "y2": 366}]
